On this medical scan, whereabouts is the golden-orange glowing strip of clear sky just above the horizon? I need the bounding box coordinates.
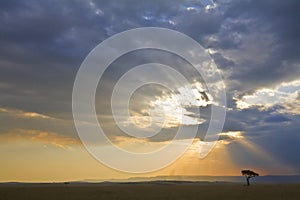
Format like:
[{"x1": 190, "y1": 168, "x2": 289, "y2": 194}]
[{"x1": 0, "y1": 129, "x2": 296, "y2": 182}]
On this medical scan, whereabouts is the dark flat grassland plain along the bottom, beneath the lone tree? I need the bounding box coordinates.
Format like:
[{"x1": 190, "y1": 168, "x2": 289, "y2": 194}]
[{"x1": 0, "y1": 182, "x2": 300, "y2": 200}]
